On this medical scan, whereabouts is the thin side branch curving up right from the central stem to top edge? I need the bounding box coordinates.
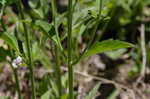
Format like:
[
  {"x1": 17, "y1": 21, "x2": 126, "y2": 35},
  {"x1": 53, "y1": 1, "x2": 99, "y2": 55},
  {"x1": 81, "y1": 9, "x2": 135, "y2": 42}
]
[{"x1": 72, "y1": 0, "x2": 102, "y2": 65}]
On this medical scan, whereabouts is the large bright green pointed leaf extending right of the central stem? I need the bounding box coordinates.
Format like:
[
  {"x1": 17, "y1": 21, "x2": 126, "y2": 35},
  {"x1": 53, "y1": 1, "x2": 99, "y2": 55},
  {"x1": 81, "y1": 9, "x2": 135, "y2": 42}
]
[{"x1": 82, "y1": 39, "x2": 133, "y2": 58}]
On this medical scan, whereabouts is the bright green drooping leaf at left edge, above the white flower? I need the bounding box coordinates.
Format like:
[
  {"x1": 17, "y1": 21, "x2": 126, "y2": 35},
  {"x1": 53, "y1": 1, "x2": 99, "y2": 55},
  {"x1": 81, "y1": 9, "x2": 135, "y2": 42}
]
[{"x1": 0, "y1": 32, "x2": 19, "y2": 52}]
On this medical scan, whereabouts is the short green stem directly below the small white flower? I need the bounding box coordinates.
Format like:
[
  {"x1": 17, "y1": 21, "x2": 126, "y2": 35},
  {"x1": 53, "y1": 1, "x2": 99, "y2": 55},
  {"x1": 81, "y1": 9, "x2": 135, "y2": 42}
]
[{"x1": 13, "y1": 68, "x2": 22, "y2": 99}]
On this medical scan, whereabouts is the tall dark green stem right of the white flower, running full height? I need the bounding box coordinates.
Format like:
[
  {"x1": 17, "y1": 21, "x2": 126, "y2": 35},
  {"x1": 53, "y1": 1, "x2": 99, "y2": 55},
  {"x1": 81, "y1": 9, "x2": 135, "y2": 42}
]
[{"x1": 17, "y1": 0, "x2": 36, "y2": 99}]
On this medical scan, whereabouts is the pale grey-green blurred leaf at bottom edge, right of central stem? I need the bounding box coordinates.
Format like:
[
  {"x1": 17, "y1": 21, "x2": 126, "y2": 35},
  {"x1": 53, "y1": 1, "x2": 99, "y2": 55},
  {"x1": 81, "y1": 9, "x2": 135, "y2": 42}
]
[{"x1": 85, "y1": 83, "x2": 100, "y2": 99}]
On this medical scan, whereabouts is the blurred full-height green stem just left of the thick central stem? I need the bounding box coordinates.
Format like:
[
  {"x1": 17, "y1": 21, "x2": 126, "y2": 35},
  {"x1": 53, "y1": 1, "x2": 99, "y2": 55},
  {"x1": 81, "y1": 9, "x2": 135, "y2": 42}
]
[{"x1": 51, "y1": 0, "x2": 62, "y2": 99}]
